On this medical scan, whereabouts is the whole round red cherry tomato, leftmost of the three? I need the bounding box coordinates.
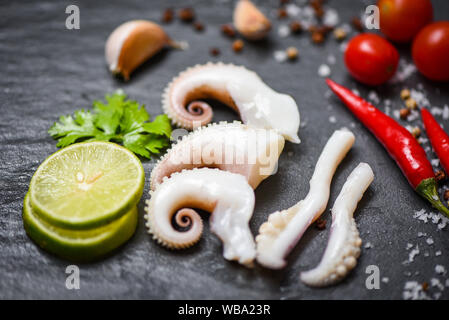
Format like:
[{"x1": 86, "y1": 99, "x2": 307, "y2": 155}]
[{"x1": 345, "y1": 33, "x2": 399, "y2": 86}]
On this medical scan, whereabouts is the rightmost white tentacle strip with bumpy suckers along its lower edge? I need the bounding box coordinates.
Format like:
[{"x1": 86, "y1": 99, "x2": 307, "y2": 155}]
[{"x1": 300, "y1": 163, "x2": 374, "y2": 287}]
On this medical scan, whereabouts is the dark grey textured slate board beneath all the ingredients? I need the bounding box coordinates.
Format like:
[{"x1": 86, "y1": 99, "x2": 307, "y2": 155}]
[{"x1": 0, "y1": 0, "x2": 449, "y2": 299}]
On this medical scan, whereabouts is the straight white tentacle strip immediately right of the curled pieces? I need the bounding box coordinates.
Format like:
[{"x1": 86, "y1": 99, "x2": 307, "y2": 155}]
[{"x1": 256, "y1": 129, "x2": 355, "y2": 269}]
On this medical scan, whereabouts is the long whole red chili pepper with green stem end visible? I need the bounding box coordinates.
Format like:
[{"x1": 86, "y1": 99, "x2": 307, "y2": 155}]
[{"x1": 326, "y1": 79, "x2": 449, "y2": 217}]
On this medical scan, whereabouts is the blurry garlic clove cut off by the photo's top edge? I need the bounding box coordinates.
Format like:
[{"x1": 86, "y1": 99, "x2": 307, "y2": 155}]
[{"x1": 233, "y1": 0, "x2": 271, "y2": 40}]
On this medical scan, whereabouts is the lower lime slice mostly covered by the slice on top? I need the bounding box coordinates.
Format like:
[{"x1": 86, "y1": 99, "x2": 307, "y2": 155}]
[{"x1": 23, "y1": 194, "x2": 138, "y2": 262}]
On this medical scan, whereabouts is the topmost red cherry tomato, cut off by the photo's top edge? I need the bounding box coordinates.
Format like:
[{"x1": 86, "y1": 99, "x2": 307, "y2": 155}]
[{"x1": 377, "y1": 0, "x2": 433, "y2": 42}]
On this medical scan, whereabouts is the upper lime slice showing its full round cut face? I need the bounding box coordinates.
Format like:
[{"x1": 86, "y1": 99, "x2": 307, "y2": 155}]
[{"x1": 30, "y1": 141, "x2": 145, "y2": 229}]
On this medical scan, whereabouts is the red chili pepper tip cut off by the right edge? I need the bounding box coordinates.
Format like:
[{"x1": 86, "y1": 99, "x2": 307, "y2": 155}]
[{"x1": 421, "y1": 108, "x2": 449, "y2": 173}]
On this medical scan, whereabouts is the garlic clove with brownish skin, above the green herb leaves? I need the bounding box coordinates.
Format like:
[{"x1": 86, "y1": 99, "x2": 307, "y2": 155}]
[{"x1": 105, "y1": 20, "x2": 171, "y2": 80}]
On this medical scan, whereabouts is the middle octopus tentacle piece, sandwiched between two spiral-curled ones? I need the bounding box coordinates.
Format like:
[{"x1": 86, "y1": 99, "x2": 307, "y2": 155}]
[{"x1": 150, "y1": 121, "x2": 285, "y2": 190}]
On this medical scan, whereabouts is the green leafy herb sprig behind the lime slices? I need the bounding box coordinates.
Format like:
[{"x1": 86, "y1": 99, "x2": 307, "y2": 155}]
[{"x1": 48, "y1": 91, "x2": 172, "y2": 158}]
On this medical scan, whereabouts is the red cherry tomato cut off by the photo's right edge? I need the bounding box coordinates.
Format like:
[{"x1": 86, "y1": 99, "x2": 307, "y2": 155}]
[{"x1": 412, "y1": 21, "x2": 449, "y2": 81}]
